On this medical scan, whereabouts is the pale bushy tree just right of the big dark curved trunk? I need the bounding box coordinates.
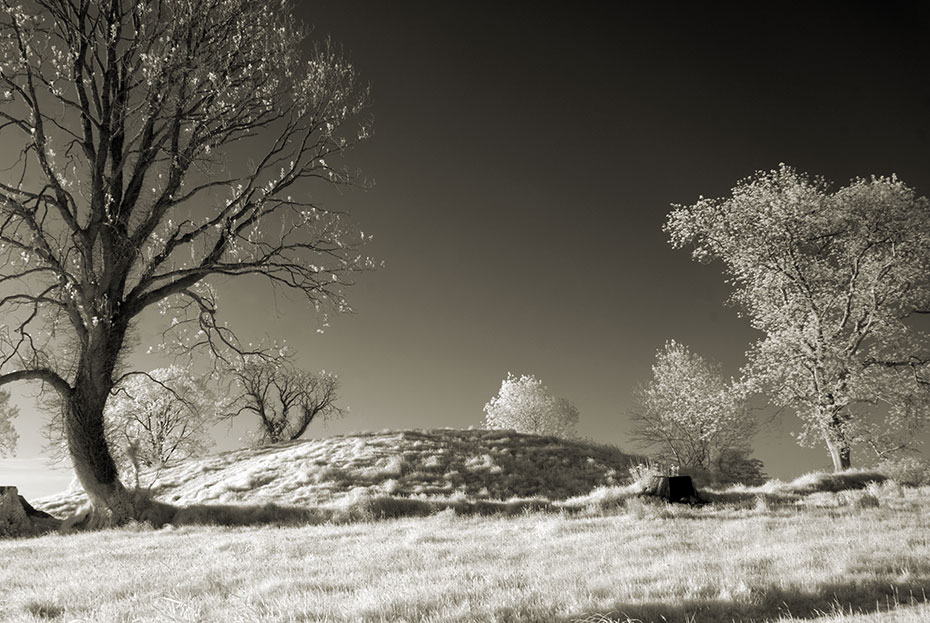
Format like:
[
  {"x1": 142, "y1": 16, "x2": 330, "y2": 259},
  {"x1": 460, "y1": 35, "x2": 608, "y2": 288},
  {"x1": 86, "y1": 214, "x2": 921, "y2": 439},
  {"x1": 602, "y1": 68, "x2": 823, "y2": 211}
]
[{"x1": 105, "y1": 365, "x2": 216, "y2": 468}]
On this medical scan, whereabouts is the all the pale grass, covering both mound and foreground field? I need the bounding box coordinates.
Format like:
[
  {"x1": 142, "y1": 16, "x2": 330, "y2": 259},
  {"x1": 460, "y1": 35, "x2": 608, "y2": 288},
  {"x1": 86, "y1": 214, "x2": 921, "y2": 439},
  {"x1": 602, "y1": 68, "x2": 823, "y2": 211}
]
[{"x1": 7, "y1": 430, "x2": 930, "y2": 623}]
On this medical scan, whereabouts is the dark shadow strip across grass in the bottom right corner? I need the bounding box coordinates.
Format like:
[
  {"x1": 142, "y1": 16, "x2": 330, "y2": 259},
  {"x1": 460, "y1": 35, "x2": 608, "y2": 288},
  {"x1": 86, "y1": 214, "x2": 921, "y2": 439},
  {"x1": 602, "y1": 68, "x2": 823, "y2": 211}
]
[{"x1": 563, "y1": 577, "x2": 930, "y2": 623}]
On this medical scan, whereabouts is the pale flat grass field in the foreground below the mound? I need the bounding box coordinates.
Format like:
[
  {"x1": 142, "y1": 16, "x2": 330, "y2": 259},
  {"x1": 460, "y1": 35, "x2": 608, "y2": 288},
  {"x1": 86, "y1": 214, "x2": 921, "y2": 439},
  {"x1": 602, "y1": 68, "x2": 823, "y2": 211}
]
[{"x1": 0, "y1": 483, "x2": 930, "y2": 623}]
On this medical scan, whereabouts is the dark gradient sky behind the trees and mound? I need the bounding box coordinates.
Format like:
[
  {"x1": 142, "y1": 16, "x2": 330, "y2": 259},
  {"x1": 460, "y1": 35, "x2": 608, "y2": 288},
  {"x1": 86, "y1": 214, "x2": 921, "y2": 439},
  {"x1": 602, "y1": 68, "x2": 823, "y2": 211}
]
[{"x1": 0, "y1": 0, "x2": 930, "y2": 497}]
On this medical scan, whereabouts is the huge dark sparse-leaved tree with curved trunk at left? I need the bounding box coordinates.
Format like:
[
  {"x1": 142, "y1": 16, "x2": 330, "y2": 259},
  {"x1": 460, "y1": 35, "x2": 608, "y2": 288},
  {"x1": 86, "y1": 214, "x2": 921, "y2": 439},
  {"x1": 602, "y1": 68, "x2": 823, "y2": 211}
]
[{"x1": 0, "y1": 0, "x2": 371, "y2": 525}]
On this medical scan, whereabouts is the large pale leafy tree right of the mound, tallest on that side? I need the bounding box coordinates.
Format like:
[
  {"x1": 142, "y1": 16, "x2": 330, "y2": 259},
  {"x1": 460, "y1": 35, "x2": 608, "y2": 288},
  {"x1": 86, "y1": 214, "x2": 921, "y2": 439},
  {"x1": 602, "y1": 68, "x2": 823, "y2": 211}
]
[{"x1": 665, "y1": 165, "x2": 930, "y2": 470}]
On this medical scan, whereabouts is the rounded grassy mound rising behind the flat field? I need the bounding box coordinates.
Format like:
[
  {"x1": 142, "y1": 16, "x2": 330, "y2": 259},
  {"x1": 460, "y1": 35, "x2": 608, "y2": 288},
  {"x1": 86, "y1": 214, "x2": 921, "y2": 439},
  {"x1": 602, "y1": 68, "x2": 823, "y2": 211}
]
[{"x1": 35, "y1": 429, "x2": 636, "y2": 517}]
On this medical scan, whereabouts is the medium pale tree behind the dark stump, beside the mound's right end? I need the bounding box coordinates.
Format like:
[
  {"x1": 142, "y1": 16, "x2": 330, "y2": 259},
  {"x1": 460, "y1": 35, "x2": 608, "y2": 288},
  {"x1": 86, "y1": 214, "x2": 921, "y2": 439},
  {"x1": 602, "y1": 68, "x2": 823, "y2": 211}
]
[{"x1": 633, "y1": 340, "x2": 756, "y2": 478}]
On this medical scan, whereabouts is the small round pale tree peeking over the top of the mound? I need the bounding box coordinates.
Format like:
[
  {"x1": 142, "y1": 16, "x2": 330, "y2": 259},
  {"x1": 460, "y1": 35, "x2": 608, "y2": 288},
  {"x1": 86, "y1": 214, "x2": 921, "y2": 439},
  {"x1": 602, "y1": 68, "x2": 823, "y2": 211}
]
[{"x1": 484, "y1": 372, "x2": 578, "y2": 438}]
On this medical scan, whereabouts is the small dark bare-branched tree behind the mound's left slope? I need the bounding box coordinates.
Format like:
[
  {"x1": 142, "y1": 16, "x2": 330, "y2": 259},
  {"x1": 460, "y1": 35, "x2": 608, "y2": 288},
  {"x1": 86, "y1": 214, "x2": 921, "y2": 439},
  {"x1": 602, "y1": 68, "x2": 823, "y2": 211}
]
[{"x1": 224, "y1": 358, "x2": 343, "y2": 444}]
